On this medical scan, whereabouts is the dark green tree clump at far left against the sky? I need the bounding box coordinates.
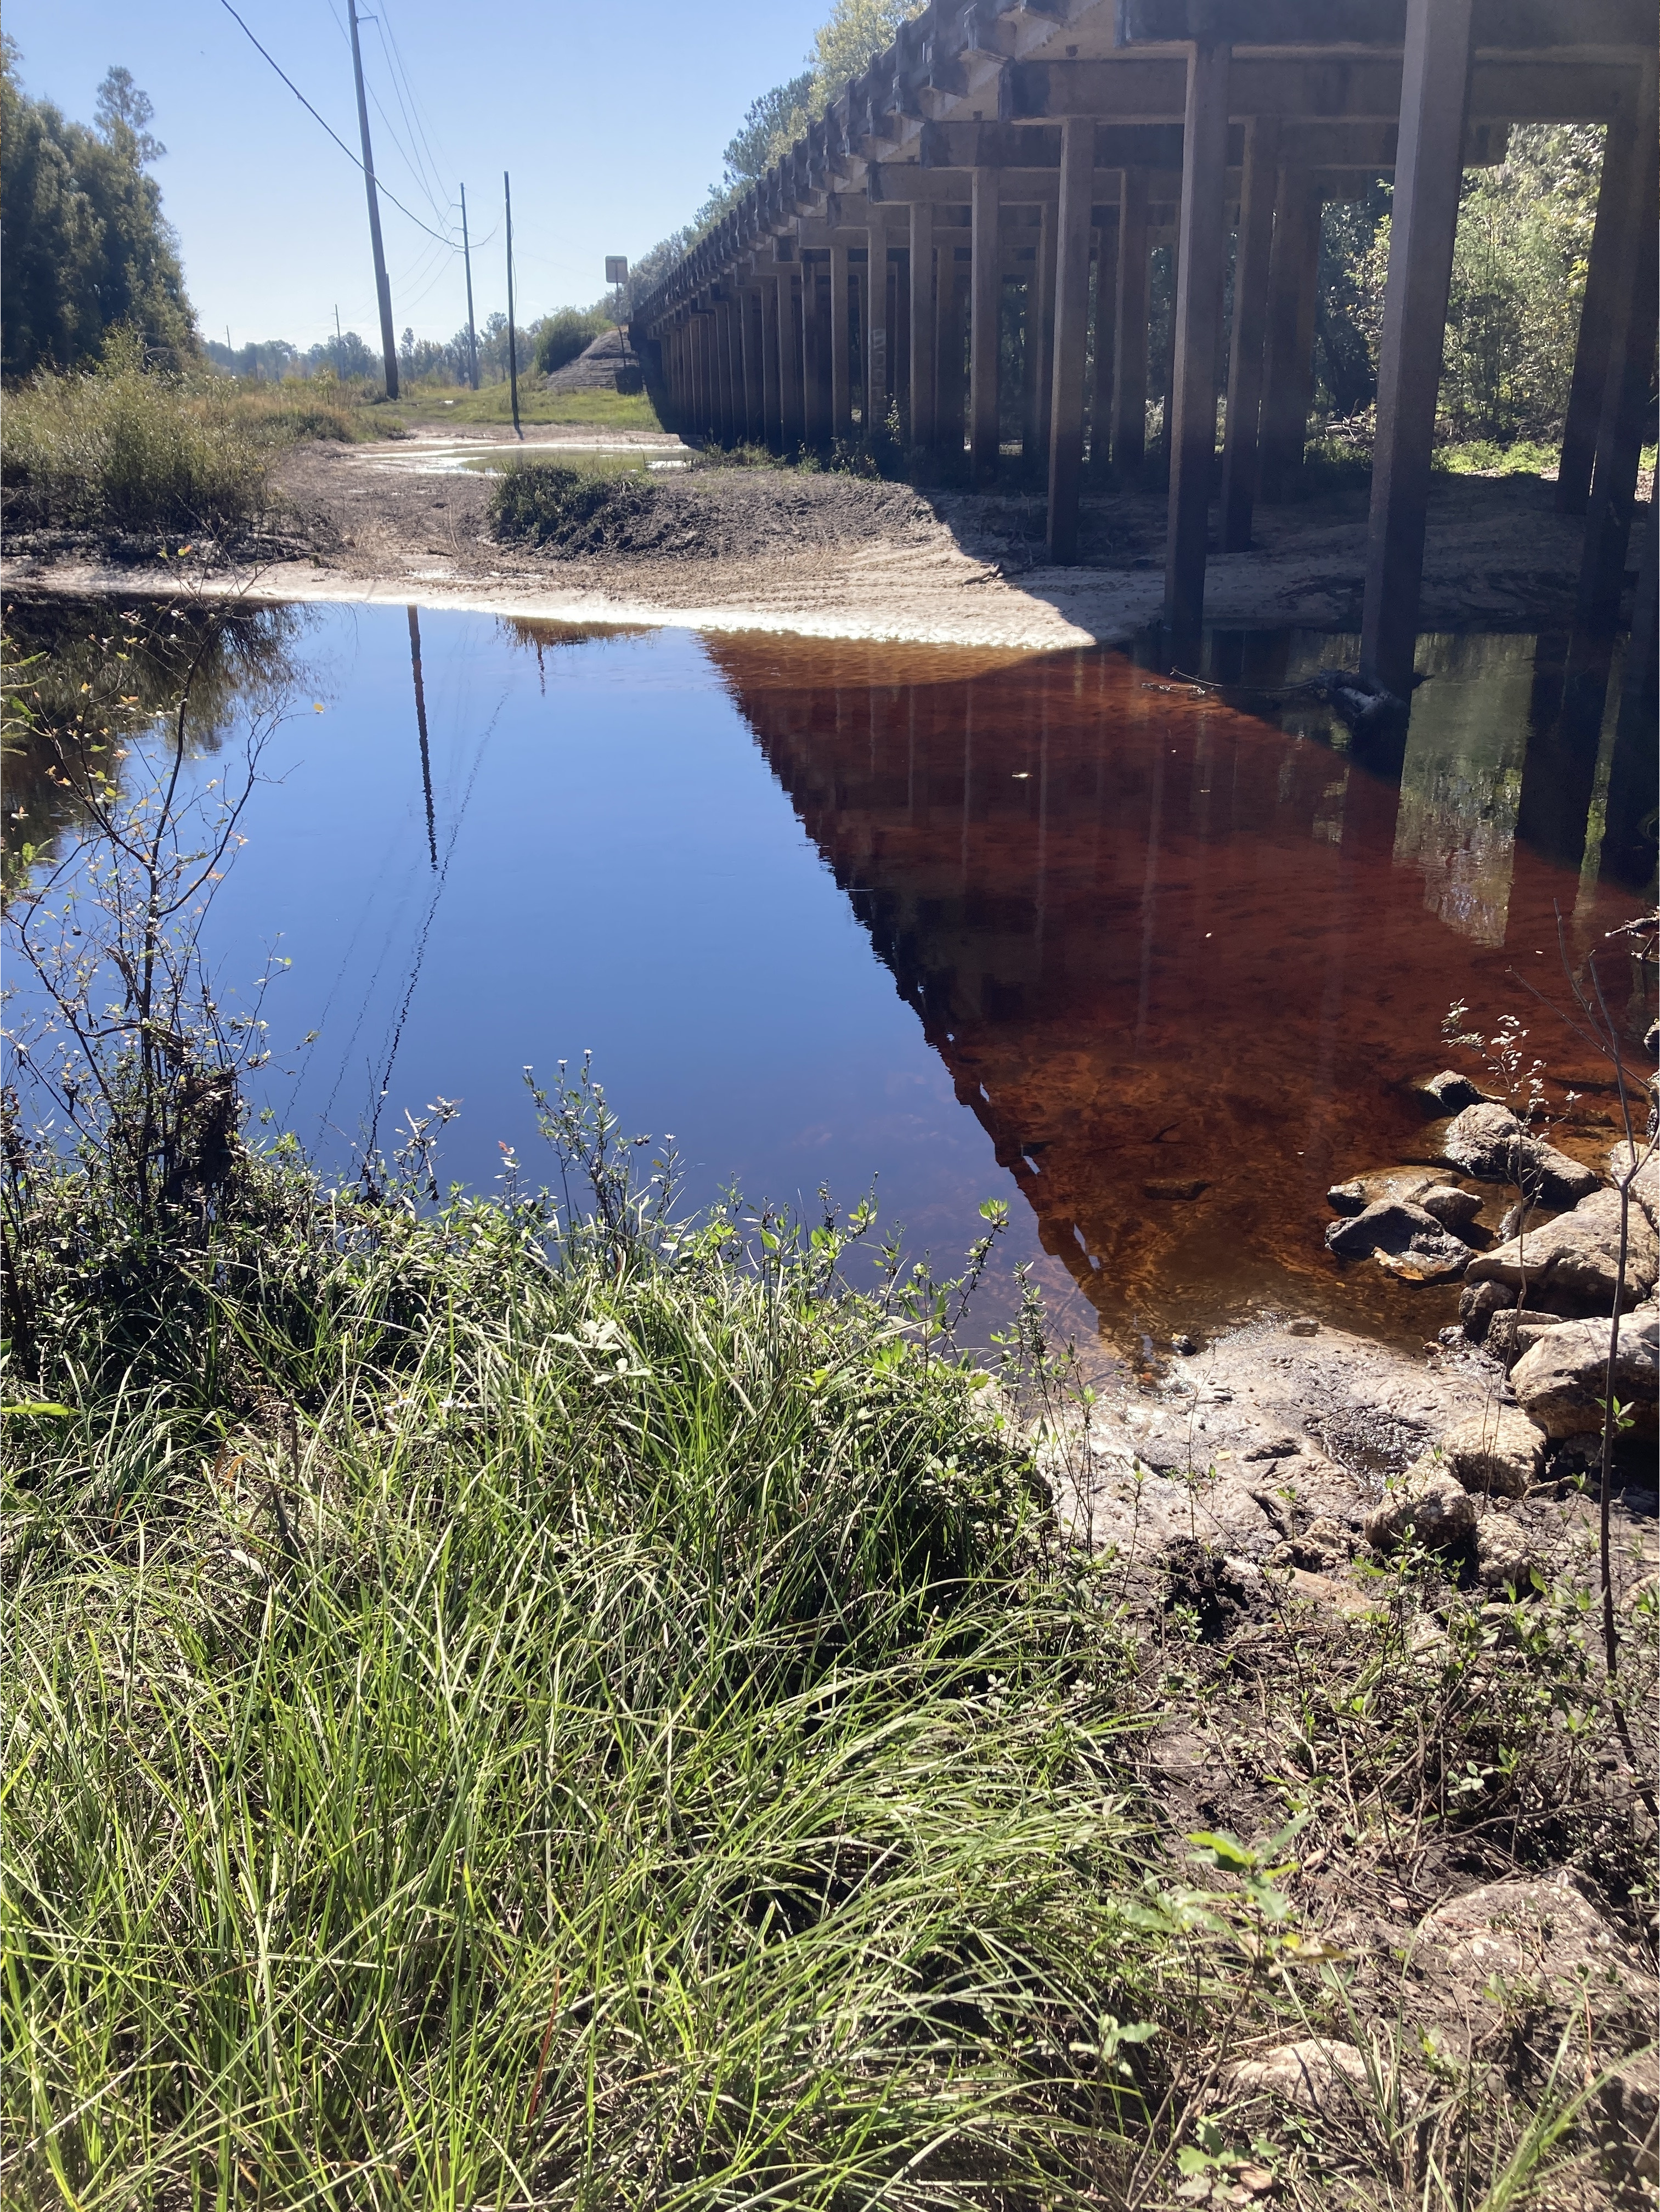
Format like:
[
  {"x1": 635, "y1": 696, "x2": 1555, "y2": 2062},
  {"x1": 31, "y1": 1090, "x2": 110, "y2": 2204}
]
[{"x1": 0, "y1": 40, "x2": 199, "y2": 378}]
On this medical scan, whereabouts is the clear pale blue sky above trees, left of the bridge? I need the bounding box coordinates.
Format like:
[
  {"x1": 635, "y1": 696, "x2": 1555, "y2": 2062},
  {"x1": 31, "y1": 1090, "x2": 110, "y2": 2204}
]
[{"x1": 7, "y1": 0, "x2": 826, "y2": 345}]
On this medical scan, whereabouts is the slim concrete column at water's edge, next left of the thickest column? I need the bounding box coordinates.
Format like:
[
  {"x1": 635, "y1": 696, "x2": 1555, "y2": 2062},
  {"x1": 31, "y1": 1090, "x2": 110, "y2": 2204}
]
[{"x1": 1164, "y1": 47, "x2": 1230, "y2": 648}]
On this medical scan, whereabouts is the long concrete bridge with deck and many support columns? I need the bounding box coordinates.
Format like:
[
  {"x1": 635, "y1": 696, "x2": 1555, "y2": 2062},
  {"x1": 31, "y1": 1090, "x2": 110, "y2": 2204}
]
[{"x1": 633, "y1": 0, "x2": 1658, "y2": 697}]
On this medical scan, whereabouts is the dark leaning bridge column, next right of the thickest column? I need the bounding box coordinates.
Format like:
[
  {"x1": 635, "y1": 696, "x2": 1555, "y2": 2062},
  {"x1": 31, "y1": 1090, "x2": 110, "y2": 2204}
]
[{"x1": 1574, "y1": 66, "x2": 1660, "y2": 628}]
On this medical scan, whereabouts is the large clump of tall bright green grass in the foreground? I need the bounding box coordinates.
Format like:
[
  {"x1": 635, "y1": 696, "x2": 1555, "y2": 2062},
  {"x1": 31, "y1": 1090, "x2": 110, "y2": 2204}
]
[{"x1": 2, "y1": 1150, "x2": 1158, "y2": 2212}]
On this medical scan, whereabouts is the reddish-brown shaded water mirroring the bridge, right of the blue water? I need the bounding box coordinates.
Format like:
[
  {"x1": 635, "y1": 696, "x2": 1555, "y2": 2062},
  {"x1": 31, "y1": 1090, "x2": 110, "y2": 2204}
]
[{"x1": 710, "y1": 637, "x2": 1655, "y2": 1336}]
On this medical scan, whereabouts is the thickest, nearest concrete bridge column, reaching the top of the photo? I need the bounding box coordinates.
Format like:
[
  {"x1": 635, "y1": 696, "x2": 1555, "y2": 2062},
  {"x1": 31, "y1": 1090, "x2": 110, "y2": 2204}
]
[{"x1": 1361, "y1": 0, "x2": 1472, "y2": 699}]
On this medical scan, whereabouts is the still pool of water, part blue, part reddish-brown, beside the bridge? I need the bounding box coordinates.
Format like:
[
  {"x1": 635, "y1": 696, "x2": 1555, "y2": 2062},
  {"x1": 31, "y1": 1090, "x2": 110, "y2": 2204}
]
[{"x1": 9, "y1": 604, "x2": 1653, "y2": 1350}]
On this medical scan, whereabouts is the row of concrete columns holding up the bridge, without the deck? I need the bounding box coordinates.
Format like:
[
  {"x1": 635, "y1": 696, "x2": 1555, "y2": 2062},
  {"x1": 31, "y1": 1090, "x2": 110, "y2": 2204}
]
[{"x1": 659, "y1": 41, "x2": 1656, "y2": 697}]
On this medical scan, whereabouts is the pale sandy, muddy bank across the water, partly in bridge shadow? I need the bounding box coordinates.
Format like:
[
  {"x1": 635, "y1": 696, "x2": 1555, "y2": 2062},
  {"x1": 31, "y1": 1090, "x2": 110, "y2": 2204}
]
[{"x1": 11, "y1": 429, "x2": 1629, "y2": 650}]
